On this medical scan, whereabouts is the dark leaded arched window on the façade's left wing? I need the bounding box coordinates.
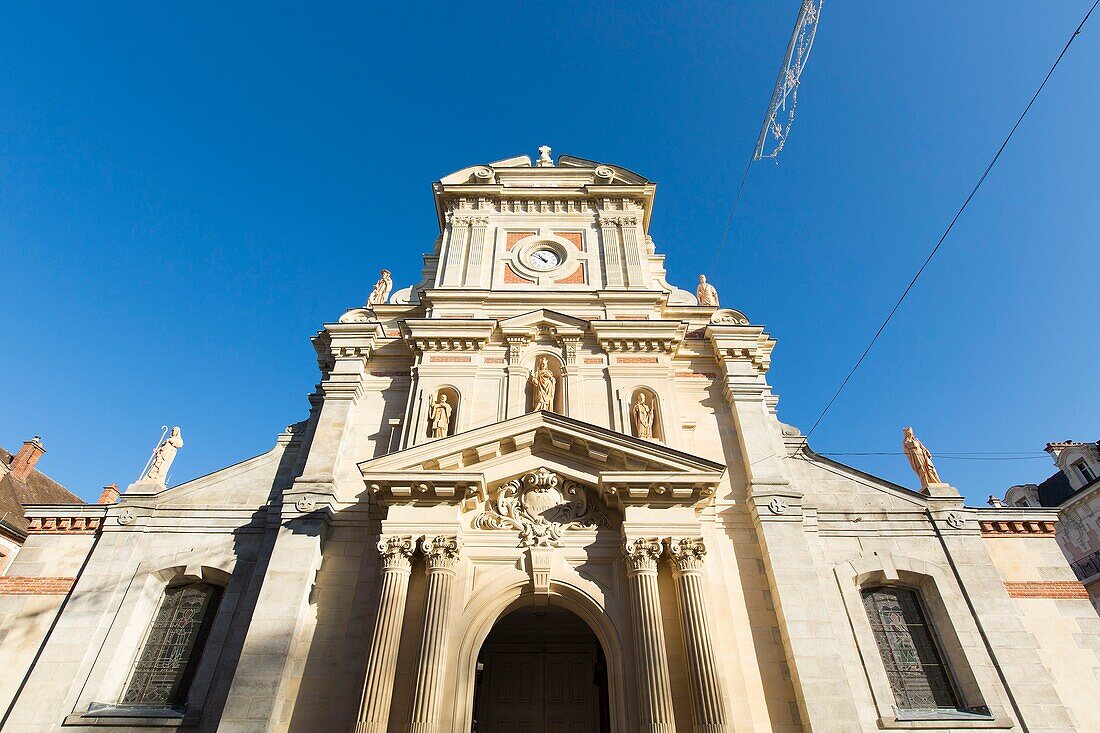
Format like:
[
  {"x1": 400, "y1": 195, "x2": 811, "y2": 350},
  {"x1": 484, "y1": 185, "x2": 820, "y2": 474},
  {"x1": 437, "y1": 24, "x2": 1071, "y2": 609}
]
[{"x1": 122, "y1": 583, "x2": 221, "y2": 708}]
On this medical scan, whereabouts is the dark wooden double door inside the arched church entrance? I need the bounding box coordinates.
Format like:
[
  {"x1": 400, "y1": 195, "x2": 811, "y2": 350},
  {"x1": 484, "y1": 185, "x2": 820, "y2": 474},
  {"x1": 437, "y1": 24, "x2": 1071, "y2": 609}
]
[{"x1": 474, "y1": 644, "x2": 600, "y2": 733}]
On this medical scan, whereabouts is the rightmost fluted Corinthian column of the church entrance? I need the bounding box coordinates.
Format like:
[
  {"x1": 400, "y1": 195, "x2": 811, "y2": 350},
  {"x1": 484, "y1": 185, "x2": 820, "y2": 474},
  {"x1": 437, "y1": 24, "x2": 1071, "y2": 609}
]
[{"x1": 664, "y1": 530, "x2": 726, "y2": 733}]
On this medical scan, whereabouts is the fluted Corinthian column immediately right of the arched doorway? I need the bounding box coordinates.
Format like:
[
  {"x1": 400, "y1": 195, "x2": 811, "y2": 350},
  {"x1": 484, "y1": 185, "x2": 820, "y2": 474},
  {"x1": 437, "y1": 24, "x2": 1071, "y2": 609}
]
[{"x1": 623, "y1": 537, "x2": 675, "y2": 733}]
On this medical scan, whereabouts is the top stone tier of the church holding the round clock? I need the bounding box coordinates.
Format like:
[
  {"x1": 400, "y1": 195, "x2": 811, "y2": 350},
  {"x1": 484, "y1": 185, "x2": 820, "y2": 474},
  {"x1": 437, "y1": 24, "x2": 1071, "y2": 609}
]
[{"x1": 394, "y1": 145, "x2": 694, "y2": 305}]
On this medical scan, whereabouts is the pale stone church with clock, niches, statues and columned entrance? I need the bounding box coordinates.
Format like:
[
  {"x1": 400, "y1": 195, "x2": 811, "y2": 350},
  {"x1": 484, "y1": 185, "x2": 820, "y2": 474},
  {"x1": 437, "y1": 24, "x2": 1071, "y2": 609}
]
[{"x1": 0, "y1": 149, "x2": 1100, "y2": 733}]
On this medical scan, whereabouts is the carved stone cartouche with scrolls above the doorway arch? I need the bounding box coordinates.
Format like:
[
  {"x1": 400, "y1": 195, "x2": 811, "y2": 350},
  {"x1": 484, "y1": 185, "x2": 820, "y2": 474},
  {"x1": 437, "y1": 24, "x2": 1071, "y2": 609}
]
[{"x1": 474, "y1": 468, "x2": 608, "y2": 547}]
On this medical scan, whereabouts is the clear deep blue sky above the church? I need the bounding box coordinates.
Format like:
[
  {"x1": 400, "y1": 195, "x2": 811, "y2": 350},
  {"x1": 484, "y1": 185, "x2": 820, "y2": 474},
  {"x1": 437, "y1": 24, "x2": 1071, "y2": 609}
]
[{"x1": 0, "y1": 0, "x2": 1100, "y2": 502}]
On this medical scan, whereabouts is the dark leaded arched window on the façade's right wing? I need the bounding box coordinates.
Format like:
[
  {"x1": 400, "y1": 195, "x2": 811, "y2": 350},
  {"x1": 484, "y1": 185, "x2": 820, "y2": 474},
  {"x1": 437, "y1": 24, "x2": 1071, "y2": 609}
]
[{"x1": 862, "y1": 587, "x2": 959, "y2": 710}]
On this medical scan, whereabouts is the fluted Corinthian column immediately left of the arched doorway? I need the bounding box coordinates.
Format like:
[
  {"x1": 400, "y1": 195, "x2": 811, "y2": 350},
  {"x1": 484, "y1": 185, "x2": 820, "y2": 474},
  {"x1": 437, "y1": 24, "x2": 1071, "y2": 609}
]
[{"x1": 408, "y1": 535, "x2": 462, "y2": 733}]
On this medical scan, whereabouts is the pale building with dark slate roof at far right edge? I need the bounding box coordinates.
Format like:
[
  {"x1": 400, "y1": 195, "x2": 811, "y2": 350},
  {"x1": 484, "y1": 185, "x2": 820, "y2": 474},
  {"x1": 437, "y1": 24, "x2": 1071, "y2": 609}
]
[{"x1": 990, "y1": 440, "x2": 1100, "y2": 612}]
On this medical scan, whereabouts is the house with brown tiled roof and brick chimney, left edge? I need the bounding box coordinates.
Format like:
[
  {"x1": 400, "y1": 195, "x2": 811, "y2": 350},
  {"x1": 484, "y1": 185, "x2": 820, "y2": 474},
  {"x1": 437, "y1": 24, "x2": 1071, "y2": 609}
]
[{"x1": 0, "y1": 436, "x2": 84, "y2": 572}]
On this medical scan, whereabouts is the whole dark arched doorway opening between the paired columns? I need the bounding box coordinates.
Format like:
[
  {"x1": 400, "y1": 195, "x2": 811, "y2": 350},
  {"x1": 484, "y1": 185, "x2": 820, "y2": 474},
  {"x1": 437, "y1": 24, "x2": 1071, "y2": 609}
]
[{"x1": 472, "y1": 605, "x2": 611, "y2": 733}]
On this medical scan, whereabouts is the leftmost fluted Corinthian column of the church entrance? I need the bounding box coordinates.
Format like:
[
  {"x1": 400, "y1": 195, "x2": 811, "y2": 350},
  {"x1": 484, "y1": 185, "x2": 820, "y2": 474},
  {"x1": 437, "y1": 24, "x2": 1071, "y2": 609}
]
[{"x1": 355, "y1": 535, "x2": 416, "y2": 733}]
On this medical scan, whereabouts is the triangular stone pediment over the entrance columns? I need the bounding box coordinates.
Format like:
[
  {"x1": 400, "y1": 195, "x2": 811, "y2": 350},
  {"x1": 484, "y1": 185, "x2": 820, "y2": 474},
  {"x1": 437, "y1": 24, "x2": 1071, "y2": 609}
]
[{"x1": 359, "y1": 412, "x2": 725, "y2": 505}]
